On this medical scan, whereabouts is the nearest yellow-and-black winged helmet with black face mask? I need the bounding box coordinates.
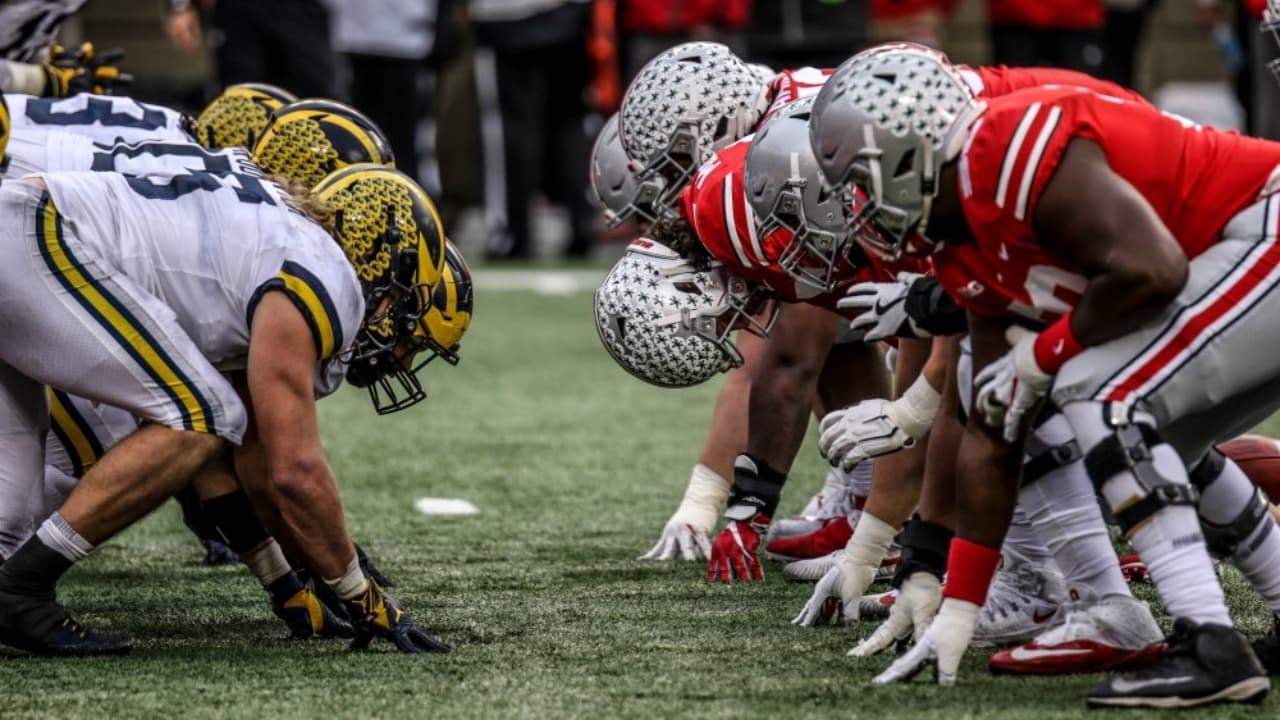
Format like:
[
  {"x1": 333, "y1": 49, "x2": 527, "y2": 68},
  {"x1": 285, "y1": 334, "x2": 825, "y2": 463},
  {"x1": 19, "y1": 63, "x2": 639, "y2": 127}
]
[{"x1": 314, "y1": 163, "x2": 445, "y2": 414}]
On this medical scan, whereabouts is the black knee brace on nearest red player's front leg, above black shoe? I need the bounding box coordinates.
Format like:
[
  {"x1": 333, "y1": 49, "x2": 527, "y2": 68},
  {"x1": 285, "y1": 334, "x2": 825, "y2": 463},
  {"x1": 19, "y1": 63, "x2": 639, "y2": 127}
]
[{"x1": 1084, "y1": 423, "x2": 1199, "y2": 536}]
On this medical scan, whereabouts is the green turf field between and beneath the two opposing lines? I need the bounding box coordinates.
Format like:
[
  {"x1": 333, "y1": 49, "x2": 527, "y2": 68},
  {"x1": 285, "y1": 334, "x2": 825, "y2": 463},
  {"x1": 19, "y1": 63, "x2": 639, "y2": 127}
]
[{"x1": 0, "y1": 272, "x2": 1280, "y2": 720}]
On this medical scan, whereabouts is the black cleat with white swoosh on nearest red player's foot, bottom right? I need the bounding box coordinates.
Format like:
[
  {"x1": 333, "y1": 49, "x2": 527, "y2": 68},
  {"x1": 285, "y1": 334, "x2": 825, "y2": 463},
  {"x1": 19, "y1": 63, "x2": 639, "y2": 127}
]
[{"x1": 1088, "y1": 620, "x2": 1271, "y2": 707}]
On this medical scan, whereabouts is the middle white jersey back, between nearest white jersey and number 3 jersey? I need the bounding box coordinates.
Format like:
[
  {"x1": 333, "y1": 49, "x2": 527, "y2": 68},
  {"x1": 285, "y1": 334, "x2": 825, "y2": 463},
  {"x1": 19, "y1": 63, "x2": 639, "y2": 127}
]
[{"x1": 0, "y1": 131, "x2": 262, "y2": 178}]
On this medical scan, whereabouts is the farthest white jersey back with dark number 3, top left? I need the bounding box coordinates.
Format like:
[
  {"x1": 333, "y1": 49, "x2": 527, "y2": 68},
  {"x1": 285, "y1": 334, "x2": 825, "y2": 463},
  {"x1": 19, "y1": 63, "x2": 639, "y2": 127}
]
[{"x1": 4, "y1": 94, "x2": 195, "y2": 145}]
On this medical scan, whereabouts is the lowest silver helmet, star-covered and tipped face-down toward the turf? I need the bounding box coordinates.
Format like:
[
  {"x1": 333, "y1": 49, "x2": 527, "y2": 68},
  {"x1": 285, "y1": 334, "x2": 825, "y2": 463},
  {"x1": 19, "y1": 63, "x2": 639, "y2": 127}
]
[{"x1": 595, "y1": 240, "x2": 777, "y2": 387}]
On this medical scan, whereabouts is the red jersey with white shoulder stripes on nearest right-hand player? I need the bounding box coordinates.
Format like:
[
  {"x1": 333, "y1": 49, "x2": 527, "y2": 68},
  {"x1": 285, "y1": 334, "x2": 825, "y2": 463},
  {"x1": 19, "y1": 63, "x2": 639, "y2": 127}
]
[{"x1": 933, "y1": 82, "x2": 1280, "y2": 323}]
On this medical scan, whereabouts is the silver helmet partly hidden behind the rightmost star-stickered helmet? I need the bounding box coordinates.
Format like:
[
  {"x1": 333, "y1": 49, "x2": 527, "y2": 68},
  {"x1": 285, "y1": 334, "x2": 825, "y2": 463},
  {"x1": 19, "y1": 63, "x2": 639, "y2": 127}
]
[{"x1": 744, "y1": 97, "x2": 849, "y2": 292}]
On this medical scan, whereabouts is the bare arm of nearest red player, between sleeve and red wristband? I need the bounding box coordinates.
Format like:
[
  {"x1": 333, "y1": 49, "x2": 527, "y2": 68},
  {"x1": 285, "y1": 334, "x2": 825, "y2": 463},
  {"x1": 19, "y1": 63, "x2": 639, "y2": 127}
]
[{"x1": 1034, "y1": 138, "x2": 1187, "y2": 346}]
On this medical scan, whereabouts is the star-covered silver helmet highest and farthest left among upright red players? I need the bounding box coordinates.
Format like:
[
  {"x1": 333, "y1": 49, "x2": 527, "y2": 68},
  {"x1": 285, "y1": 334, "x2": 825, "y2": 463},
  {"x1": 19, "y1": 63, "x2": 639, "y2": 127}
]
[{"x1": 618, "y1": 42, "x2": 768, "y2": 214}]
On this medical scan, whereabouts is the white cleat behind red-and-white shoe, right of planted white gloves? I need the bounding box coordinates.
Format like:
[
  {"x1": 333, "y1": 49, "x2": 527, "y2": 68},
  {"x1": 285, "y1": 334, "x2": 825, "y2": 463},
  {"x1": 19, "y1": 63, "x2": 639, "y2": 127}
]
[{"x1": 973, "y1": 550, "x2": 1068, "y2": 647}]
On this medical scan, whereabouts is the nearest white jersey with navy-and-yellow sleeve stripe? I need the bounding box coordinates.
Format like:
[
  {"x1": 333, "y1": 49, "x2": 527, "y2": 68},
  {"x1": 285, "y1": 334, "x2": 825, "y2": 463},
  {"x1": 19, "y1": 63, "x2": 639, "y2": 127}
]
[{"x1": 41, "y1": 172, "x2": 365, "y2": 395}]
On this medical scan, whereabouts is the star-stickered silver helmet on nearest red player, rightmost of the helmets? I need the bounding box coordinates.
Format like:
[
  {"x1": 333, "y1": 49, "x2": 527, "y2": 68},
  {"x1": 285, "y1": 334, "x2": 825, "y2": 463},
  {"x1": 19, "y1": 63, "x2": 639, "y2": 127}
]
[{"x1": 809, "y1": 47, "x2": 984, "y2": 259}]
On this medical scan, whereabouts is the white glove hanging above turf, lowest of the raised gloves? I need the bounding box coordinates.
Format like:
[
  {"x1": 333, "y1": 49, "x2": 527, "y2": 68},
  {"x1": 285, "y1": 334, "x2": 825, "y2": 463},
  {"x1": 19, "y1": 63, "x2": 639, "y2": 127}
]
[{"x1": 818, "y1": 375, "x2": 942, "y2": 473}]
